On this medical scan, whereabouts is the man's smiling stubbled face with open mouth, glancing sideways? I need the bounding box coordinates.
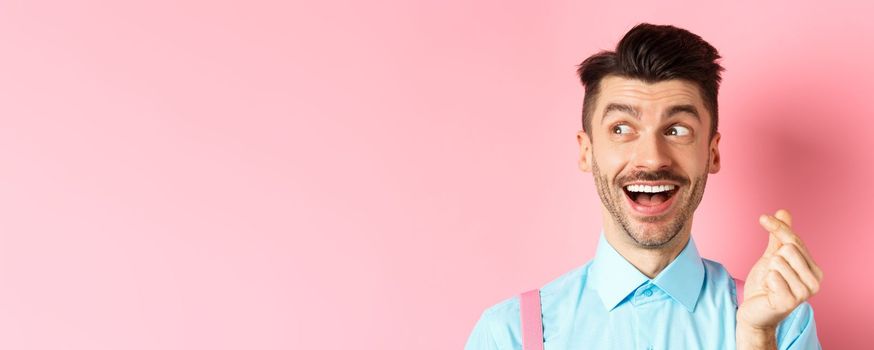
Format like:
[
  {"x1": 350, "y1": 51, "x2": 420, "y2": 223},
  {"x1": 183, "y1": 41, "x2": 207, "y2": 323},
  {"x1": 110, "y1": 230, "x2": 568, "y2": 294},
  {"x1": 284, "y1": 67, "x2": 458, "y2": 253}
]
[{"x1": 577, "y1": 76, "x2": 720, "y2": 248}]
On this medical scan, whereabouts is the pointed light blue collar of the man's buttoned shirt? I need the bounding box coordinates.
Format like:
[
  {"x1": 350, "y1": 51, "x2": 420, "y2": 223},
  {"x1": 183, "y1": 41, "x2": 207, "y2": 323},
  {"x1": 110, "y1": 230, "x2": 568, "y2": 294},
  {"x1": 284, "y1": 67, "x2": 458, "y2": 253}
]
[{"x1": 592, "y1": 229, "x2": 704, "y2": 312}]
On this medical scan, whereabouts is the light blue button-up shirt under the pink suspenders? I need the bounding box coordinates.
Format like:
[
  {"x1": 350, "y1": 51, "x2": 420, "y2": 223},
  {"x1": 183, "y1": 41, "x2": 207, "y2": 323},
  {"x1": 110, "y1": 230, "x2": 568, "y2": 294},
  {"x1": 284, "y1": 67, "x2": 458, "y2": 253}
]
[{"x1": 465, "y1": 231, "x2": 822, "y2": 350}]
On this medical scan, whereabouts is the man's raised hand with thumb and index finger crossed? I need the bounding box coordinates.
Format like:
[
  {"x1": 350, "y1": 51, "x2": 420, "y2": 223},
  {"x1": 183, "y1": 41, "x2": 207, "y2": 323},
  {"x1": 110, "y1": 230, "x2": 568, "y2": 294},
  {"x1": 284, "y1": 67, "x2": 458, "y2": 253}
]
[{"x1": 737, "y1": 209, "x2": 822, "y2": 331}]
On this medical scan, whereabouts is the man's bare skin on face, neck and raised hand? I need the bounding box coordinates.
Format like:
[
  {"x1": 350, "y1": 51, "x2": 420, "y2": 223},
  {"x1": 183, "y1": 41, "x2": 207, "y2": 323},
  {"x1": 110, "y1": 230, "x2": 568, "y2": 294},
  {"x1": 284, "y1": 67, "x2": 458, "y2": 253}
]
[{"x1": 577, "y1": 76, "x2": 822, "y2": 349}]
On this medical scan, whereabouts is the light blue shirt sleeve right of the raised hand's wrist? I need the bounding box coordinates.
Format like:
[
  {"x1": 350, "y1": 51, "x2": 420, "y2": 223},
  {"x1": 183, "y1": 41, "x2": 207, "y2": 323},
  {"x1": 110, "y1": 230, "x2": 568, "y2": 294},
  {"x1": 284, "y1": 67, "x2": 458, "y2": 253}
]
[{"x1": 777, "y1": 301, "x2": 822, "y2": 350}]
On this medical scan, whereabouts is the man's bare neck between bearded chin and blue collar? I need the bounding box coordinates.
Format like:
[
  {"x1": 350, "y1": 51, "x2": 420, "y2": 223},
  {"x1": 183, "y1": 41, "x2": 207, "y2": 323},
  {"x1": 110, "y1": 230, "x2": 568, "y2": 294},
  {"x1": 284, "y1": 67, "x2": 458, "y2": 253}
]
[{"x1": 604, "y1": 213, "x2": 692, "y2": 279}]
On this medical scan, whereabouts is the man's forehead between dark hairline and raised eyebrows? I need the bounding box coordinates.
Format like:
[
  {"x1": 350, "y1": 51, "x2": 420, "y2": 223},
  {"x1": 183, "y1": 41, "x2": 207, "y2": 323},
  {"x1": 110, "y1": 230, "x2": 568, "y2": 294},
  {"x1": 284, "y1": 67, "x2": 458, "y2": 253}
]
[{"x1": 597, "y1": 76, "x2": 706, "y2": 113}]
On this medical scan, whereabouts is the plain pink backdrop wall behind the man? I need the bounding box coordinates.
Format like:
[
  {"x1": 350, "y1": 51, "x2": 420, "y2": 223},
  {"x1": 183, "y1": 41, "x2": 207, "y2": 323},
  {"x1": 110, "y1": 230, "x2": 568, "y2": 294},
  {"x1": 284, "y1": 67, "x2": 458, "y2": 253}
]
[{"x1": 0, "y1": 0, "x2": 874, "y2": 349}]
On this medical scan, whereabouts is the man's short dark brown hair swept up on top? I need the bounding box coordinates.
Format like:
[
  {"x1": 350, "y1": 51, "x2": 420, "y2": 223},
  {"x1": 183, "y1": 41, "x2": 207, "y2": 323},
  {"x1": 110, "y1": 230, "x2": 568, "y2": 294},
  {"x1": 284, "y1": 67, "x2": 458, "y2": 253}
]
[{"x1": 577, "y1": 23, "x2": 725, "y2": 138}]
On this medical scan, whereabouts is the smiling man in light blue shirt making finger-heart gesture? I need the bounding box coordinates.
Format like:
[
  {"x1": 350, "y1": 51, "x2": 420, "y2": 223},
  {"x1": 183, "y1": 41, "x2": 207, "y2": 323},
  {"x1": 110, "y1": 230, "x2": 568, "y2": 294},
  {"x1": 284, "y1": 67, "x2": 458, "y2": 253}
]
[{"x1": 466, "y1": 24, "x2": 823, "y2": 350}]
